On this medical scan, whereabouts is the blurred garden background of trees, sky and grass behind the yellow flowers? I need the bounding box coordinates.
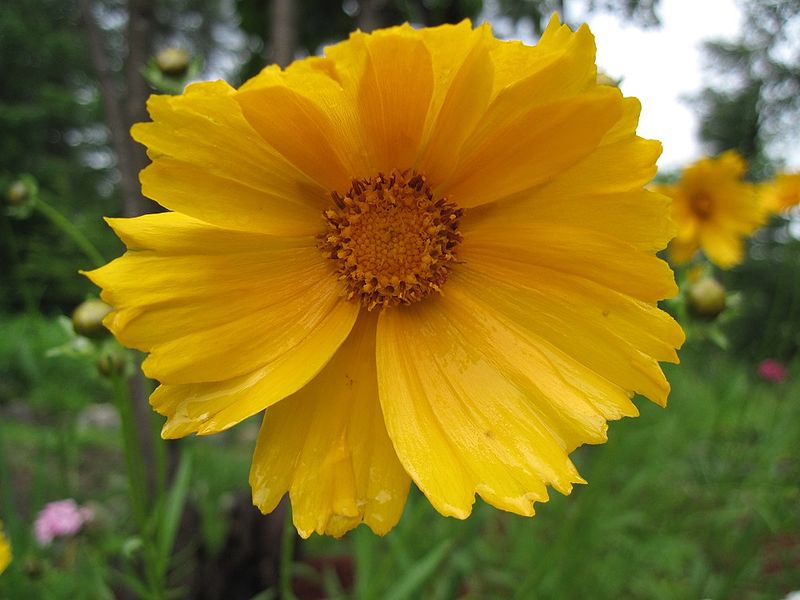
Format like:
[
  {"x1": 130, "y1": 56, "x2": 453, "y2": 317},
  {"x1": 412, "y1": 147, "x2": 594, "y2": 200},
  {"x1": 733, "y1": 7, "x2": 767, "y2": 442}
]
[{"x1": 0, "y1": 0, "x2": 800, "y2": 600}]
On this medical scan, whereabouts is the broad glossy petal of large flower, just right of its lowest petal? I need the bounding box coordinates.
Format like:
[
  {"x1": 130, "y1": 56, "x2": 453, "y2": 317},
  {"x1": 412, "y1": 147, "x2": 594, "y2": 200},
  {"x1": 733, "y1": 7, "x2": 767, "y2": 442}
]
[{"x1": 377, "y1": 298, "x2": 582, "y2": 518}]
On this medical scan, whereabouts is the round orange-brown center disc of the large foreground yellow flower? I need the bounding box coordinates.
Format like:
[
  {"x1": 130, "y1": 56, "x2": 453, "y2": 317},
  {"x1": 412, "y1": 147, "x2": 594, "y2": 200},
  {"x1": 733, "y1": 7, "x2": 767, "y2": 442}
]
[{"x1": 319, "y1": 170, "x2": 463, "y2": 310}]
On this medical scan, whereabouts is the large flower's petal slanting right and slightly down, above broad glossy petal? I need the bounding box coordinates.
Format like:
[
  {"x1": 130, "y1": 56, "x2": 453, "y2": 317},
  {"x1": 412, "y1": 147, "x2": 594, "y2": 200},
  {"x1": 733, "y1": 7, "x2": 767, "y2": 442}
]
[{"x1": 448, "y1": 263, "x2": 684, "y2": 406}]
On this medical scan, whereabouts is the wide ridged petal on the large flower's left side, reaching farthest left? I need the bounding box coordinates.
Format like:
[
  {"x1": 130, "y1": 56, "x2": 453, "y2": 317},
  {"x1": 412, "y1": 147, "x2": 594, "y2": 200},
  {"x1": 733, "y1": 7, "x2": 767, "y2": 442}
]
[{"x1": 87, "y1": 213, "x2": 359, "y2": 433}]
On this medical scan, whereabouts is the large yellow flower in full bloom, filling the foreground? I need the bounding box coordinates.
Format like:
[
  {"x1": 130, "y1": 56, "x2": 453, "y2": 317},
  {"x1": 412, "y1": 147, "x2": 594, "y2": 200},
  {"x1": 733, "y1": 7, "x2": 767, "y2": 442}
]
[{"x1": 89, "y1": 18, "x2": 683, "y2": 536}]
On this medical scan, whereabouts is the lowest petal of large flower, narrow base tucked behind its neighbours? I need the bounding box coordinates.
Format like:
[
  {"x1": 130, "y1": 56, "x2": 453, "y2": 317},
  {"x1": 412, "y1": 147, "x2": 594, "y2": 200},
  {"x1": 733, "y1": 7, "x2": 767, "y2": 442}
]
[{"x1": 250, "y1": 313, "x2": 410, "y2": 538}]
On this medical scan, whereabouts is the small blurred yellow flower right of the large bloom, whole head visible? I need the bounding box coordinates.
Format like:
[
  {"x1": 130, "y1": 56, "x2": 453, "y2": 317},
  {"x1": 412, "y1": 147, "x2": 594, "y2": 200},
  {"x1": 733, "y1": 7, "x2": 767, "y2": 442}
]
[{"x1": 654, "y1": 150, "x2": 765, "y2": 269}]
